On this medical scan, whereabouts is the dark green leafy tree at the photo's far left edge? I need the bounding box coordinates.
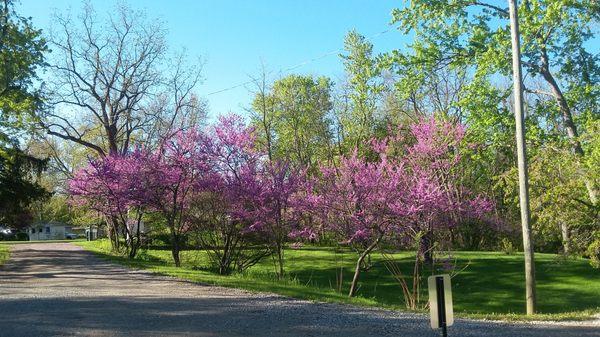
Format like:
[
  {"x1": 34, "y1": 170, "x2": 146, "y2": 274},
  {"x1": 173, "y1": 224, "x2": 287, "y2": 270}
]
[{"x1": 0, "y1": 0, "x2": 48, "y2": 227}]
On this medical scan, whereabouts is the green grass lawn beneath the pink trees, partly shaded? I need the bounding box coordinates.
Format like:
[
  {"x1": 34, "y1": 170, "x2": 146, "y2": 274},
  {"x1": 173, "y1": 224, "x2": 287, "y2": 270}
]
[{"x1": 78, "y1": 241, "x2": 600, "y2": 320}]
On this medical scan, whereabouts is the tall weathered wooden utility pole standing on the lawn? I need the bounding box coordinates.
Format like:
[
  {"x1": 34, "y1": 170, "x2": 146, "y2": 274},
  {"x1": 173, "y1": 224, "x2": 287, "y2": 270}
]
[{"x1": 508, "y1": 0, "x2": 536, "y2": 315}]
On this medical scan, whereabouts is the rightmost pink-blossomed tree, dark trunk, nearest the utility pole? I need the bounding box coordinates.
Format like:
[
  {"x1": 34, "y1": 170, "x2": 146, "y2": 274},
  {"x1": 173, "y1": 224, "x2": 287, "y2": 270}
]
[{"x1": 395, "y1": 117, "x2": 493, "y2": 264}]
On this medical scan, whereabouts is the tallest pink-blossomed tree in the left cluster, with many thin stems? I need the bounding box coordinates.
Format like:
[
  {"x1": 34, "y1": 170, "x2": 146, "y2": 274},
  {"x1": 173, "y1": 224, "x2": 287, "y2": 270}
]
[{"x1": 194, "y1": 115, "x2": 271, "y2": 274}]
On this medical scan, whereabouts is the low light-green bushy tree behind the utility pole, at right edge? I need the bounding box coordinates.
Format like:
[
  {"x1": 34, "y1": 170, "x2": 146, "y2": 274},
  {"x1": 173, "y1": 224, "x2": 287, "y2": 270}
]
[{"x1": 499, "y1": 143, "x2": 599, "y2": 254}]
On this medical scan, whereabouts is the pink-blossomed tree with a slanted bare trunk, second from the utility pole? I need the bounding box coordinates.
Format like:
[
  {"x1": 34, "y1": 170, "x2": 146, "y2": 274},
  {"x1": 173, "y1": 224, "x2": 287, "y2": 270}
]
[{"x1": 304, "y1": 151, "x2": 406, "y2": 296}]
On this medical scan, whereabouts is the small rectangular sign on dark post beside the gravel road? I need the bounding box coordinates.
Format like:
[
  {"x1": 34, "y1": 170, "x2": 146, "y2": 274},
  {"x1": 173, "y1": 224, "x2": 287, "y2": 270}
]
[{"x1": 427, "y1": 274, "x2": 454, "y2": 337}]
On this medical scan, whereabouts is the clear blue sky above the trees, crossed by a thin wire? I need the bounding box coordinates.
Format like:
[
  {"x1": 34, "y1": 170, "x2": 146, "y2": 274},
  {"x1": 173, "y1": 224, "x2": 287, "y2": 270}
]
[{"x1": 17, "y1": 0, "x2": 407, "y2": 116}]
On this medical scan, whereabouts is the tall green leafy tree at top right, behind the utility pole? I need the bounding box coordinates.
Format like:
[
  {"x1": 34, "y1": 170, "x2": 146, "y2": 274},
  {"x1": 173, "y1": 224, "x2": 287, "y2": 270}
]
[{"x1": 390, "y1": 0, "x2": 600, "y2": 204}]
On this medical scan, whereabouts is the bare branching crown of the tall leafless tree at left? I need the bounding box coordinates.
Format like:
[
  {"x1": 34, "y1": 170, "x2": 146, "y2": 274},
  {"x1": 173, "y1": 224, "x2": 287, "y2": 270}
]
[{"x1": 42, "y1": 4, "x2": 203, "y2": 156}]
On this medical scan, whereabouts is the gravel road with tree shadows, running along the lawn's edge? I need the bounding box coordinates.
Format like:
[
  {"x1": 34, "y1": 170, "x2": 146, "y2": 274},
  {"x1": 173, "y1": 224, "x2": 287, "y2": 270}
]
[{"x1": 0, "y1": 243, "x2": 600, "y2": 337}]
